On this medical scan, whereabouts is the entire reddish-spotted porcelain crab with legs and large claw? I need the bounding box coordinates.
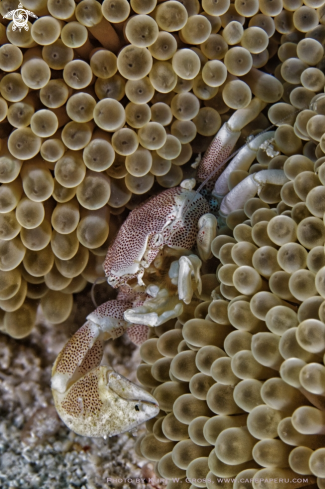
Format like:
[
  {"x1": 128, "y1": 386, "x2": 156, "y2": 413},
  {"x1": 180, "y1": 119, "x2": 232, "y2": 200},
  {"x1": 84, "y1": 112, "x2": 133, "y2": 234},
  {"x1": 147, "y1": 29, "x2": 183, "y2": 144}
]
[{"x1": 52, "y1": 98, "x2": 283, "y2": 437}]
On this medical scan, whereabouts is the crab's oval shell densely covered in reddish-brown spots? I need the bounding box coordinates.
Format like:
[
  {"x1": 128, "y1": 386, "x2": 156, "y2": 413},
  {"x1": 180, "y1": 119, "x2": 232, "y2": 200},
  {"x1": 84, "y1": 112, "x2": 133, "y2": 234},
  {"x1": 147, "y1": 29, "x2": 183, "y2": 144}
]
[{"x1": 104, "y1": 187, "x2": 209, "y2": 287}]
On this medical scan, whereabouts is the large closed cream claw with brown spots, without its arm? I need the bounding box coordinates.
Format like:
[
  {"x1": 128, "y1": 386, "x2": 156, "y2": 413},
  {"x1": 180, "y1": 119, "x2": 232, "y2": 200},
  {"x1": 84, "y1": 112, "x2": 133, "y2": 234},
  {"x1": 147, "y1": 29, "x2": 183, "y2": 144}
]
[{"x1": 53, "y1": 366, "x2": 159, "y2": 437}]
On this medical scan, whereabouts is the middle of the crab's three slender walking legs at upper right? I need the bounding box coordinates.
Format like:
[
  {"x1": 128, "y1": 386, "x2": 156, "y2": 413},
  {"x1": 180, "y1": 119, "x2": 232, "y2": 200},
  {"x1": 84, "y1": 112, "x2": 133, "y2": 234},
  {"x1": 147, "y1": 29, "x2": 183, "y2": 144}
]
[{"x1": 212, "y1": 131, "x2": 275, "y2": 197}]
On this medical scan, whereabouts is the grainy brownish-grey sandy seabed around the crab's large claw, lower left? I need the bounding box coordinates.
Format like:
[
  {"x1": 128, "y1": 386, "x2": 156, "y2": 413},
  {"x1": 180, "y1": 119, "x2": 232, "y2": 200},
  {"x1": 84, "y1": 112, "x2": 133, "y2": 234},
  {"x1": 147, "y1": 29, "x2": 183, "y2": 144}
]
[{"x1": 0, "y1": 282, "x2": 158, "y2": 489}]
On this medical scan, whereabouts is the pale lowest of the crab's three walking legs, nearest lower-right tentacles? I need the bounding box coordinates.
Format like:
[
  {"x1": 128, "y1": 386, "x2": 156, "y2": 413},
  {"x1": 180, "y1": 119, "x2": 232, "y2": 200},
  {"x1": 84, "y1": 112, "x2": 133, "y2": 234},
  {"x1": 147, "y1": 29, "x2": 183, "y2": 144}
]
[{"x1": 220, "y1": 170, "x2": 288, "y2": 216}]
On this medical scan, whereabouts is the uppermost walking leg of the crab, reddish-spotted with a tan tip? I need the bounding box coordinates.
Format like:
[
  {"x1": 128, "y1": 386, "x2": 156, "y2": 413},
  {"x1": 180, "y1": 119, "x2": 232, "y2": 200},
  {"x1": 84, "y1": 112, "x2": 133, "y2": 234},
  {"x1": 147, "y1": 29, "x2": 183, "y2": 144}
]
[{"x1": 197, "y1": 97, "x2": 266, "y2": 190}]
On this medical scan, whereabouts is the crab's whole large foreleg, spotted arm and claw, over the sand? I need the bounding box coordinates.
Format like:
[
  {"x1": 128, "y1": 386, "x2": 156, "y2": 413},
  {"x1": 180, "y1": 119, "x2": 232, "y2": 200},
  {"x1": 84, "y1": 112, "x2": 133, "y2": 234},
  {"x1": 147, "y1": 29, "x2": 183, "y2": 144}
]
[{"x1": 52, "y1": 300, "x2": 159, "y2": 437}]
